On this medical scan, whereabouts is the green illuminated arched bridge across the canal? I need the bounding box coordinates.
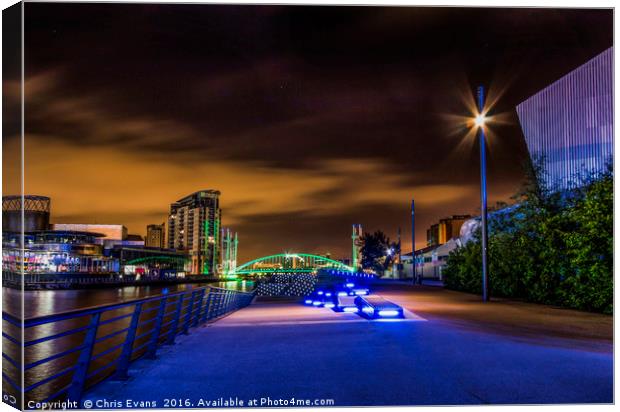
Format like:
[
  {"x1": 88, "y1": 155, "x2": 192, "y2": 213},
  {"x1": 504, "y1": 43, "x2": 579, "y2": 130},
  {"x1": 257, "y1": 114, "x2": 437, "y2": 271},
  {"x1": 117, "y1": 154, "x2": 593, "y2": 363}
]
[{"x1": 230, "y1": 253, "x2": 353, "y2": 275}]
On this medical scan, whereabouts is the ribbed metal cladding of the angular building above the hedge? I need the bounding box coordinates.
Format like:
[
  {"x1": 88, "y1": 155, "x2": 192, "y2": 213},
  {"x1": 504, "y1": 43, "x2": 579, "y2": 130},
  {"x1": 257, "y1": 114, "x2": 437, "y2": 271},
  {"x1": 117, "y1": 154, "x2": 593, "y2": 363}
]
[{"x1": 517, "y1": 47, "x2": 614, "y2": 191}]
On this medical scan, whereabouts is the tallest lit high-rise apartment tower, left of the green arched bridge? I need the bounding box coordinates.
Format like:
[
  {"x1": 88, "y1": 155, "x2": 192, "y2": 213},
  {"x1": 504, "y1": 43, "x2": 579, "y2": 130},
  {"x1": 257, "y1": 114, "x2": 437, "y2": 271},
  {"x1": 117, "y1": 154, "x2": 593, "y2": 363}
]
[{"x1": 168, "y1": 190, "x2": 222, "y2": 275}]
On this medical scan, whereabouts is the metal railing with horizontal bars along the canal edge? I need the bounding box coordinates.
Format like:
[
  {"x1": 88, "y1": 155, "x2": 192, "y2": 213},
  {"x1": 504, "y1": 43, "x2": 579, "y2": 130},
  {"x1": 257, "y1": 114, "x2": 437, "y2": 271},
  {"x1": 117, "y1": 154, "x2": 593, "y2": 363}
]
[{"x1": 2, "y1": 286, "x2": 254, "y2": 402}]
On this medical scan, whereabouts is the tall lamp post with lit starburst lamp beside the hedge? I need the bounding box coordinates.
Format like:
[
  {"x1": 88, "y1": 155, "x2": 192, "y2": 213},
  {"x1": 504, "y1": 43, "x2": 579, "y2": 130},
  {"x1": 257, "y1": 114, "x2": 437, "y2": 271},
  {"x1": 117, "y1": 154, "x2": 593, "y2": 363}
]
[{"x1": 474, "y1": 86, "x2": 489, "y2": 302}]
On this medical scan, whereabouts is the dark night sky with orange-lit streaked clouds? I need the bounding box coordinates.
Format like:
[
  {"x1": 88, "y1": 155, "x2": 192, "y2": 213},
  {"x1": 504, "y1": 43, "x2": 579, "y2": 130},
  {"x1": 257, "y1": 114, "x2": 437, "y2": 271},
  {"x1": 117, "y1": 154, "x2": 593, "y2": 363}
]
[{"x1": 3, "y1": 3, "x2": 613, "y2": 261}]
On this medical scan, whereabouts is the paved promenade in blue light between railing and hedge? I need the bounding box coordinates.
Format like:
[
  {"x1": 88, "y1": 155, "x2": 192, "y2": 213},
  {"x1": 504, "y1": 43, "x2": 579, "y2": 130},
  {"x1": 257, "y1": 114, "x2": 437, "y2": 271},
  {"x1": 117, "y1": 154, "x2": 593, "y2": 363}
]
[{"x1": 85, "y1": 286, "x2": 613, "y2": 407}]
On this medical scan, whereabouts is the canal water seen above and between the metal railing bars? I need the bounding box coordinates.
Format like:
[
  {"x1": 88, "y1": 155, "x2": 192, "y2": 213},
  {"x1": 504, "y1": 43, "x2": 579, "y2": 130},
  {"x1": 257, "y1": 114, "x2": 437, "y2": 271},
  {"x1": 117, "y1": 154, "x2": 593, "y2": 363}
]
[{"x1": 2, "y1": 281, "x2": 254, "y2": 400}]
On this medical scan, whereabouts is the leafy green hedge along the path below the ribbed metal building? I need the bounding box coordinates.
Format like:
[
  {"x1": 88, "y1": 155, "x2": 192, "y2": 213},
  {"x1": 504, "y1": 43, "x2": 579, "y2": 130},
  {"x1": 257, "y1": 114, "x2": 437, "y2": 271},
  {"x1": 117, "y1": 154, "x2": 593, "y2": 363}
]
[{"x1": 443, "y1": 168, "x2": 613, "y2": 314}]
